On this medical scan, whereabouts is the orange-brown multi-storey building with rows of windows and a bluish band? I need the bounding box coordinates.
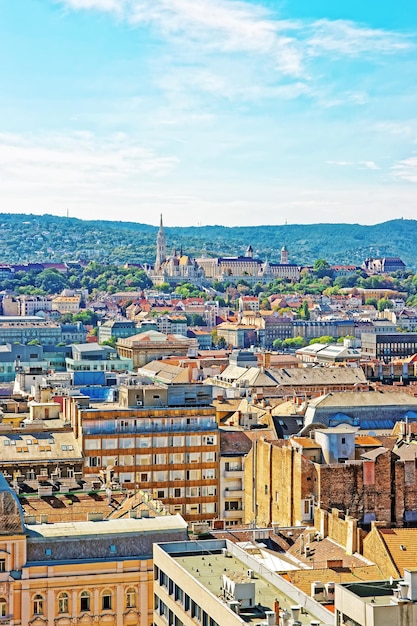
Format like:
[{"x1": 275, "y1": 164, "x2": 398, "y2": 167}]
[{"x1": 70, "y1": 400, "x2": 220, "y2": 521}]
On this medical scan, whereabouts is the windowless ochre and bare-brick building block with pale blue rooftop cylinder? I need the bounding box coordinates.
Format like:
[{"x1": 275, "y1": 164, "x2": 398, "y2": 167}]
[{"x1": 245, "y1": 424, "x2": 417, "y2": 527}]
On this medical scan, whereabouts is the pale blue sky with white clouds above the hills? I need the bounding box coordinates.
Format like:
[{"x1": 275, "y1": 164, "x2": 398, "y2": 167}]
[{"x1": 0, "y1": 0, "x2": 417, "y2": 226}]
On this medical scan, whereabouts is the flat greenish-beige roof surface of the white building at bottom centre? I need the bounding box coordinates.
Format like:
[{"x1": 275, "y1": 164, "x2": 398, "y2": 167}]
[{"x1": 171, "y1": 543, "x2": 322, "y2": 626}]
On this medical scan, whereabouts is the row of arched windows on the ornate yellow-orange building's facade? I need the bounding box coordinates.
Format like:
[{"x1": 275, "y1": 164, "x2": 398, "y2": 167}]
[{"x1": 26, "y1": 587, "x2": 137, "y2": 617}]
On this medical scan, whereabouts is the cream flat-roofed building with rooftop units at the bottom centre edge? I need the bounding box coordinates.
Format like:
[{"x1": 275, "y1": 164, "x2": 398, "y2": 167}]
[{"x1": 154, "y1": 539, "x2": 328, "y2": 626}]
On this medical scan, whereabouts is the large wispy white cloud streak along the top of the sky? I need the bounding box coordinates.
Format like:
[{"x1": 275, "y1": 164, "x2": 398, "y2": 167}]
[{"x1": 60, "y1": 0, "x2": 411, "y2": 77}]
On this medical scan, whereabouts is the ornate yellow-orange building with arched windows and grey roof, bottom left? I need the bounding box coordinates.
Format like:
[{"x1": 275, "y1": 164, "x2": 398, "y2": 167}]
[{"x1": 0, "y1": 476, "x2": 186, "y2": 626}]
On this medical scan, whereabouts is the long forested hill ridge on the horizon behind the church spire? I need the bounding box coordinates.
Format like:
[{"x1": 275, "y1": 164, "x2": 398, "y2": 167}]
[{"x1": 0, "y1": 213, "x2": 417, "y2": 269}]
